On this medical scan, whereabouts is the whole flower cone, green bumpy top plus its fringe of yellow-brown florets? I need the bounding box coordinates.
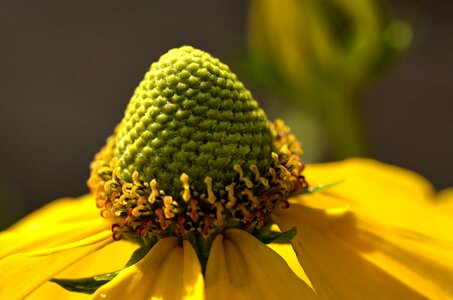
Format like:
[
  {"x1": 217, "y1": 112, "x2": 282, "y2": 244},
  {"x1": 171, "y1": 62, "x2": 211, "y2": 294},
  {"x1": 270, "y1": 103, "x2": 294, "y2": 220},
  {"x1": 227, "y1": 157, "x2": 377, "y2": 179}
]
[{"x1": 88, "y1": 46, "x2": 307, "y2": 240}]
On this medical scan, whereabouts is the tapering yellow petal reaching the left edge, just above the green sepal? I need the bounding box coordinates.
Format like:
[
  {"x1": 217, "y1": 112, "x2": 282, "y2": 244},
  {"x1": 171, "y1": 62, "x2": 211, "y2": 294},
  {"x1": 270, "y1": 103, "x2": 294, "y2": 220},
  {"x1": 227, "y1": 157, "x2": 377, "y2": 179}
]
[{"x1": 0, "y1": 231, "x2": 112, "y2": 299}]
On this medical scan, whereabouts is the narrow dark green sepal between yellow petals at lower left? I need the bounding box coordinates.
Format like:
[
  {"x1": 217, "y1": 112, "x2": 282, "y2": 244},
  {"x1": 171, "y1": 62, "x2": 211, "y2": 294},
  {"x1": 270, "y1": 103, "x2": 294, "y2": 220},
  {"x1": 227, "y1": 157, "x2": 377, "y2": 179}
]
[{"x1": 49, "y1": 238, "x2": 157, "y2": 294}]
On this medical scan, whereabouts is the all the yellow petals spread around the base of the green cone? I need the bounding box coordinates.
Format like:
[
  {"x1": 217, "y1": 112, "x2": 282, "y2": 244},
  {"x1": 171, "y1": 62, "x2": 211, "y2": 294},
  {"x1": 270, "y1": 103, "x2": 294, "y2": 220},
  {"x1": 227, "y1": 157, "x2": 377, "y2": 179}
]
[{"x1": 0, "y1": 159, "x2": 453, "y2": 299}]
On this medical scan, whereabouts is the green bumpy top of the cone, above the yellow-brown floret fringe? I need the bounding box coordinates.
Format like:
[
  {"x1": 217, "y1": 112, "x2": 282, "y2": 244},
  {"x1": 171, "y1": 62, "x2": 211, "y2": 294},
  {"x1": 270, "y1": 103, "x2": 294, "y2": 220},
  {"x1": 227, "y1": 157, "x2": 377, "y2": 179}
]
[{"x1": 113, "y1": 46, "x2": 274, "y2": 197}]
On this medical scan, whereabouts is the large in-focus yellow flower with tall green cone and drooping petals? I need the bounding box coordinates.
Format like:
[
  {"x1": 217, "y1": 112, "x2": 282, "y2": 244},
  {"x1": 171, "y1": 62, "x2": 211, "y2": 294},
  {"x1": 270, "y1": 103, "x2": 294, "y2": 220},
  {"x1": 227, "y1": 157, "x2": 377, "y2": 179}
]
[{"x1": 0, "y1": 47, "x2": 453, "y2": 299}]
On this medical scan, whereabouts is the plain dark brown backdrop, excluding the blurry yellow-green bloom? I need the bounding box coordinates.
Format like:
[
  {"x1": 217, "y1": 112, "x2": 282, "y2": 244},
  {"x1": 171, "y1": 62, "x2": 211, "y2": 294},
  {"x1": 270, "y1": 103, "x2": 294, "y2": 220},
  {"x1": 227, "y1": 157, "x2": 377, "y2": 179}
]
[{"x1": 0, "y1": 0, "x2": 453, "y2": 228}]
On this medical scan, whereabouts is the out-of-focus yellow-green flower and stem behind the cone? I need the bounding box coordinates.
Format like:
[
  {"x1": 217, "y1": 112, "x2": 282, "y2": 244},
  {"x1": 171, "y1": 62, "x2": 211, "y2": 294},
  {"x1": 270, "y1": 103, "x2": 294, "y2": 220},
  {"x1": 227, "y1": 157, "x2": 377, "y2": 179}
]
[{"x1": 246, "y1": 0, "x2": 412, "y2": 161}]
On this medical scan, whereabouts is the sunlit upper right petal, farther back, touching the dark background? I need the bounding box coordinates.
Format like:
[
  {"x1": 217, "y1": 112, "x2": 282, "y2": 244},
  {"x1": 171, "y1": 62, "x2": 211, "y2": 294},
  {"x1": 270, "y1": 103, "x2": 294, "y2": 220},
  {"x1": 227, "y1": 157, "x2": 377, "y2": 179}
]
[{"x1": 291, "y1": 159, "x2": 453, "y2": 243}]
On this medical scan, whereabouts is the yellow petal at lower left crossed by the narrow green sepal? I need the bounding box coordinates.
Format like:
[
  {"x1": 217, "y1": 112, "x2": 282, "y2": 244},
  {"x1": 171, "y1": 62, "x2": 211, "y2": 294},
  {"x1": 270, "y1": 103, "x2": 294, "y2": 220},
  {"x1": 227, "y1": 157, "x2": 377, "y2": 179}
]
[{"x1": 27, "y1": 240, "x2": 138, "y2": 300}]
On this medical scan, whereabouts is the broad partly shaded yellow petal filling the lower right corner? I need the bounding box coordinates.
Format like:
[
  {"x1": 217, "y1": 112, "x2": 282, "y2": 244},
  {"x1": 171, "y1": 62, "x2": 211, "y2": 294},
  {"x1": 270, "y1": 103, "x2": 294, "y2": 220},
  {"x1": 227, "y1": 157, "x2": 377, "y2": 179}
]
[{"x1": 275, "y1": 205, "x2": 453, "y2": 299}]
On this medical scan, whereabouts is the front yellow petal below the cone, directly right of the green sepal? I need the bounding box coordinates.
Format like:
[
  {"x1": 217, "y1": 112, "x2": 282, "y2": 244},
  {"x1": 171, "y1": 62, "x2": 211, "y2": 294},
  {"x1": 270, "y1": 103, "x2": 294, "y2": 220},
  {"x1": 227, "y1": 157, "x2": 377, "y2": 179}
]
[{"x1": 93, "y1": 237, "x2": 203, "y2": 300}]
